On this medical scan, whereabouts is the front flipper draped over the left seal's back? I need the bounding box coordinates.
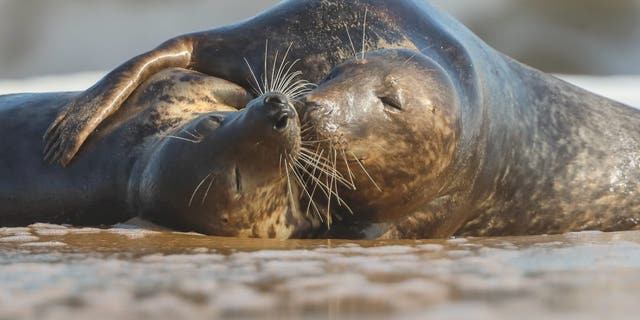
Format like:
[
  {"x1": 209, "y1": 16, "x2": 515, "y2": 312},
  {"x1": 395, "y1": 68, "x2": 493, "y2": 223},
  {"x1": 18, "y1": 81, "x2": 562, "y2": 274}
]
[{"x1": 44, "y1": 36, "x2": 193, "y2": 166}]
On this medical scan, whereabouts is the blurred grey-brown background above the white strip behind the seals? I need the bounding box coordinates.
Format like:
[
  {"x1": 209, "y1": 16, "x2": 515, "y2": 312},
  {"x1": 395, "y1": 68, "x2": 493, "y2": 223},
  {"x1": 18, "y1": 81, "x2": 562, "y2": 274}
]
[{"x1": 0, "y1": 0, "x2": 640, "y2": 79}]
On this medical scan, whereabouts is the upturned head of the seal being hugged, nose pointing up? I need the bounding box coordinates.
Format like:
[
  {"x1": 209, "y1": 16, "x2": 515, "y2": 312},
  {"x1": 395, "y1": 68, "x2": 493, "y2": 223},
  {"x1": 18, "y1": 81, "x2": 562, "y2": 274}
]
[{"x1": 137, "y1": 93, "x2": 307, "y2": 239}]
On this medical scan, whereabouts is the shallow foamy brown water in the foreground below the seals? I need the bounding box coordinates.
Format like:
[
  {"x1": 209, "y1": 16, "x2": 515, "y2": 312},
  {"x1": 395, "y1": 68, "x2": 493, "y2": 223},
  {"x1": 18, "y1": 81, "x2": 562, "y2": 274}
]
[{"x1": 0, "y1": 225, "x2": 640, "y2": 319}]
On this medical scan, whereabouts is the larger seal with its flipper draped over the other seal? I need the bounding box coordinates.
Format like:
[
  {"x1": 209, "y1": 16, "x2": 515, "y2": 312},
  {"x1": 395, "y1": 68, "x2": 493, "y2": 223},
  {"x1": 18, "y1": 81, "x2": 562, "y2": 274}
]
[{"x1": 22, "y1": 0, "x2": 640, "y2": 238}]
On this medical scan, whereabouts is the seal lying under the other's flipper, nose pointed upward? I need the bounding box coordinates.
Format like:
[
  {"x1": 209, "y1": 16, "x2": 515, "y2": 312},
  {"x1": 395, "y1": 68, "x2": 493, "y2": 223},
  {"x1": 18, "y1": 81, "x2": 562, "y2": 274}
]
[{"x1": 0, "y1": 69, "x2": 314, "y2": 238}]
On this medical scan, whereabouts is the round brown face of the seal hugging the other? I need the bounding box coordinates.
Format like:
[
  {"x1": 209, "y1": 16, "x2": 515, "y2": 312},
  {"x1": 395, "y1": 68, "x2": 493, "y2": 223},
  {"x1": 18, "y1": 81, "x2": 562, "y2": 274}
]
[{"x1": 304, "y1": 50, "x2": 461, "y2": 225}]
